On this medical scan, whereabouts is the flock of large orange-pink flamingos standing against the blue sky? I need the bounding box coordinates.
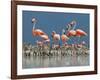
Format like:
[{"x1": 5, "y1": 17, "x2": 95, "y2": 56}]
[{"x1": 32, "y1": 18, "x2": 87, "y2": 46}]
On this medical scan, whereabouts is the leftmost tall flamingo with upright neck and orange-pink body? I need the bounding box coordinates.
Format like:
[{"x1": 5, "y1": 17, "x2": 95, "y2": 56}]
[{"x1": 32, "y1": 18, "x2": 45, "y2": 36}]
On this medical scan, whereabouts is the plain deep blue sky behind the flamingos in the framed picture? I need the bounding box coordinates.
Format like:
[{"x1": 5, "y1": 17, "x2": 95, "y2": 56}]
[{"x1": 22, "y1": 11, "x2": 90, "y2": 46}]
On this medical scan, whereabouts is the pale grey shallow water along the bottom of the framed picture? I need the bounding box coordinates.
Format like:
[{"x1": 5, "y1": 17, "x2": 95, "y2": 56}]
[{"x1": 22, "y1": 54, "x2": 89, "y2": 69}]
